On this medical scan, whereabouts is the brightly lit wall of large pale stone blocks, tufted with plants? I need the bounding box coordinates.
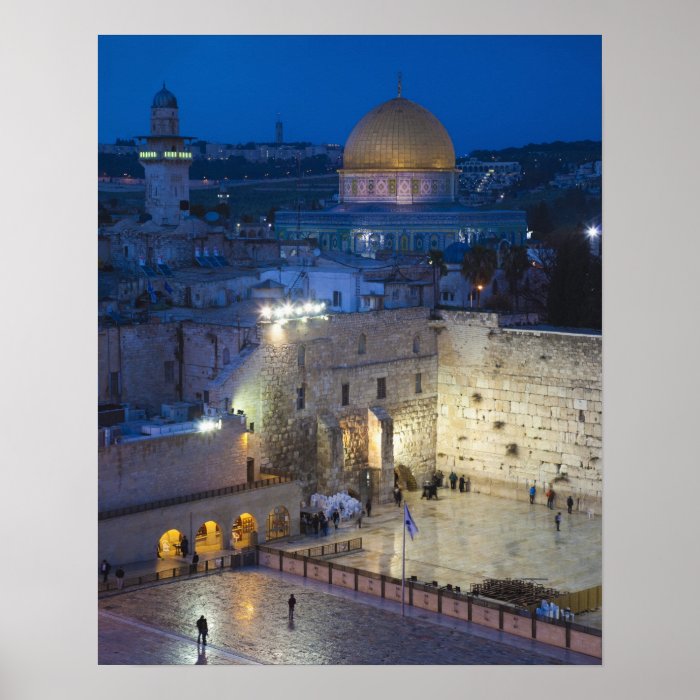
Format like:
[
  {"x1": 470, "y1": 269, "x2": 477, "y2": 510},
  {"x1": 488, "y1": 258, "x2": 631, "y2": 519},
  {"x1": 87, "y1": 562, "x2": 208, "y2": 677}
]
[{"x1": 436, "y1": 312, "x2": 602, "y2": 507}]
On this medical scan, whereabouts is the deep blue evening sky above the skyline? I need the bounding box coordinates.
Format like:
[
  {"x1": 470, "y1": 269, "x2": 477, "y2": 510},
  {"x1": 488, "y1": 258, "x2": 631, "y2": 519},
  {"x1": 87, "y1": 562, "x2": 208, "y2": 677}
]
[{"x1": 98, "y1": 35, "x2": 602, "y2": 154}]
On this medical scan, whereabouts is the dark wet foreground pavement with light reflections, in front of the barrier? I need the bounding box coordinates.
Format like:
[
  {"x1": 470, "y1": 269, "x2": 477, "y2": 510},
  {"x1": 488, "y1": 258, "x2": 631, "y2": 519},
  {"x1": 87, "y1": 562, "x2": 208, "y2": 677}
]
[{"x1": 99, "y1": 568, "x2": 598, "y2": 665}]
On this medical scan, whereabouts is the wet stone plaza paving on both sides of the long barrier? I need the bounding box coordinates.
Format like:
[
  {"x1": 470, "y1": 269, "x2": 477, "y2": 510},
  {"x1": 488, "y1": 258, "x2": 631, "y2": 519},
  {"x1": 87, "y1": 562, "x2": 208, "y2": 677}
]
[{"x1": 99, "y1": 488, "x2": 602, "y2": 665}]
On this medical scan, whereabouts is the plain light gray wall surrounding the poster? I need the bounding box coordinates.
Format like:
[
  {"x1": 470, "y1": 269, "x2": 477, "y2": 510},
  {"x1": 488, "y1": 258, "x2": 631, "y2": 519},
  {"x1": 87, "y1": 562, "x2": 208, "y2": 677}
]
[{"x1": 0, "y1": 0, "x2": 700, "y2": 700}]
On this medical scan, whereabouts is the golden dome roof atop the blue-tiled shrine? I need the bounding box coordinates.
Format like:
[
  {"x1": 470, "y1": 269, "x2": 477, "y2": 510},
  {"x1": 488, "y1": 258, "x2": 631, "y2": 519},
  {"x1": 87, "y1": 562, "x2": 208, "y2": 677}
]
[{"x1": 343, "y1": 97, "x2": 455, "y2": 170}]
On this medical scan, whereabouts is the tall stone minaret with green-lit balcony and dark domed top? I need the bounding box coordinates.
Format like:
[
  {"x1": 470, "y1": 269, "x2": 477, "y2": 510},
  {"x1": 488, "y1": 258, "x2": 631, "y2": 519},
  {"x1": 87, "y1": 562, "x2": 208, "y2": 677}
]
[{"x1": 138, "y1": 83, "x2": 193, "y2": 225}]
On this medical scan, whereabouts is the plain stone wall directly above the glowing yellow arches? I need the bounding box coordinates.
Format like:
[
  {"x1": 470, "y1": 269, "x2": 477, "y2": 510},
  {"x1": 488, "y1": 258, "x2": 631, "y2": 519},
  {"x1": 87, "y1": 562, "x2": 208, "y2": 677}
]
[{"x1": 98, "y1": 416, "x2": 247, "y2": 511}]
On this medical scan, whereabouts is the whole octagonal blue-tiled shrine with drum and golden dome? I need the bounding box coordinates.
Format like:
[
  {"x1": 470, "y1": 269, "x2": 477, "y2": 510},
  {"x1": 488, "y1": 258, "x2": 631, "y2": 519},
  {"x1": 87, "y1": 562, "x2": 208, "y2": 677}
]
[{"x1": 275, "y1": 88, "x2": 527, "y2": 257}]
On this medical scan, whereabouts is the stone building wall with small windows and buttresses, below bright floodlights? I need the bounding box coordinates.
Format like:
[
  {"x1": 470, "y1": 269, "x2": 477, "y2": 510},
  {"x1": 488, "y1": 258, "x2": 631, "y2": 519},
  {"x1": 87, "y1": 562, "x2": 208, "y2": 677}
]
[{"x1": 226, "y1": 307, "x2": 437, "y2": 502}]
